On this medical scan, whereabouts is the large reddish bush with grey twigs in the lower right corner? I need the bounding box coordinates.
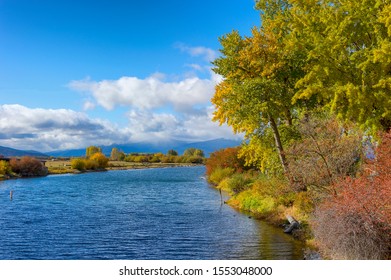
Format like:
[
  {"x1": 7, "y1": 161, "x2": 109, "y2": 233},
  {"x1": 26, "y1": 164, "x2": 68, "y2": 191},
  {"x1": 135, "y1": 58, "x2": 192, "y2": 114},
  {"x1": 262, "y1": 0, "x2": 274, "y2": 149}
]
[{"x1": 313, "y1": 133, "x2": 391, "y2": 259}]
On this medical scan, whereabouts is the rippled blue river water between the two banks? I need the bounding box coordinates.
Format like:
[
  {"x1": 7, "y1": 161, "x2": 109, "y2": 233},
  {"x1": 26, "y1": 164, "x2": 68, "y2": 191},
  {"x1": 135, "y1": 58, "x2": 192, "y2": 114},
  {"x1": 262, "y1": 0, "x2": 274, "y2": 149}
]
[{"x1": 0, "y1": 167, "x2": 303, "y2": 260}]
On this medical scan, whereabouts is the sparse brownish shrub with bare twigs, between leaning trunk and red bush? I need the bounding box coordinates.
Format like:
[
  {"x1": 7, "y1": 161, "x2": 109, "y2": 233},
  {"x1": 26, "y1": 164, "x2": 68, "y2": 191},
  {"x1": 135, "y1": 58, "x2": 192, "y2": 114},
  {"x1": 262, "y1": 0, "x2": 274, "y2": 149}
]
[{"x1": 286, "y1": 116, "x2": 362, "y2": 192}]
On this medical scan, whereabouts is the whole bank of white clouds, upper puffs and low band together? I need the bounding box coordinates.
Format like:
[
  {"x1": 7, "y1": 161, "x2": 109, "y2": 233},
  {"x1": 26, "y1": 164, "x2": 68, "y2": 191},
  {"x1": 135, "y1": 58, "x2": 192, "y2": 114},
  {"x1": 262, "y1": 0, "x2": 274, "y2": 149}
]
[{"x1": 0, "y1": 44, "x2": 239, "y2": 152}]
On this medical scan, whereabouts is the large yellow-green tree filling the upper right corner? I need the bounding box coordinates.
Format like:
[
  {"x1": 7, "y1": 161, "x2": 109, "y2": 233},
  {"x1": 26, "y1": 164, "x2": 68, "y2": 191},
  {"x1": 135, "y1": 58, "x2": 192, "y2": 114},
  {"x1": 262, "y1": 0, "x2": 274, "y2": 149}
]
[{"x1": 278, "y1": 0, "x2": 391, "y2": 132}]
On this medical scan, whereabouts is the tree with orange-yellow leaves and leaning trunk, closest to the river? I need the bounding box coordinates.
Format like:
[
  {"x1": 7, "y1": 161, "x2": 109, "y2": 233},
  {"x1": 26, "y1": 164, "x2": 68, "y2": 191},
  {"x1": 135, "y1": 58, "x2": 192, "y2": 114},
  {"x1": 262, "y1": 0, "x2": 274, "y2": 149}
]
[{"x1": 212, "y1": 19, "x2": 302, "y2": 173}]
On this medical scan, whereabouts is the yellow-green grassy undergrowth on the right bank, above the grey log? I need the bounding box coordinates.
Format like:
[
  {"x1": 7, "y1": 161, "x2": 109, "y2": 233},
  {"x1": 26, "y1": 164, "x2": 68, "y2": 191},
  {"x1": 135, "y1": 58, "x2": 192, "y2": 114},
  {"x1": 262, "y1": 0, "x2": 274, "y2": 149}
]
[{"x1": 209, "y1": 170, "x2": 314, "y2": 243}]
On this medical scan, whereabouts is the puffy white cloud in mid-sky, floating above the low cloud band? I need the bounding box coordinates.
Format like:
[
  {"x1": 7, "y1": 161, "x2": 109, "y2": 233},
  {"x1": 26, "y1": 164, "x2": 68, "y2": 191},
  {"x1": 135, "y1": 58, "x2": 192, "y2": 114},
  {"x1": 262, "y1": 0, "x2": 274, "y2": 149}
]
[{"x1": 69, "y1": 75, "x2": 215, "y2": 111}]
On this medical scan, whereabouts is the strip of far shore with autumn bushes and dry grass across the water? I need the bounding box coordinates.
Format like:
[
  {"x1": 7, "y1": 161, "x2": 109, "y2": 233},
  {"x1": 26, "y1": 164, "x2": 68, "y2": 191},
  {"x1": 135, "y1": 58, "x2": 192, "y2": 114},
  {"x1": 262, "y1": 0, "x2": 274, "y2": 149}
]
[{"x1": 0, "y1": 146, "x2": 205, "y2": 180}]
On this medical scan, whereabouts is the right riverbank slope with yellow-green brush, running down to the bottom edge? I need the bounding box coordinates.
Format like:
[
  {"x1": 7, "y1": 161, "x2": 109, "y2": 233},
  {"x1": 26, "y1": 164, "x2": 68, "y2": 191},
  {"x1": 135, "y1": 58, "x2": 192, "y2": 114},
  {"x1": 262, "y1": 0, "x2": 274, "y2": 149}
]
[{"x1": 211, "y1": 178, "x2": 324, "y2": 259}]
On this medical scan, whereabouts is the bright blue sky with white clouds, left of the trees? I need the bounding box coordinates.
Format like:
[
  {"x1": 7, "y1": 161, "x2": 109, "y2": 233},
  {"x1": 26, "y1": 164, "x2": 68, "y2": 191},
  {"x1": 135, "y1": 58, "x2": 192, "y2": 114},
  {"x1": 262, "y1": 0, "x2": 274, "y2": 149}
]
[{"x1": 0, "y1": 0, "x2": 260, "y2": 152}]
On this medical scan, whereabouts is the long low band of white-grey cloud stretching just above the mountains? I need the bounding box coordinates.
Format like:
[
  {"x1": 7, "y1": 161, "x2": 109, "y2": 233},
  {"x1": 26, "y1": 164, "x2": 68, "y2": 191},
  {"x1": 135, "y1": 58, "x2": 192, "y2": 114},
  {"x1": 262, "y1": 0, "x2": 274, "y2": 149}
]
[{"x1": 0, "y1": 104, "x2": 239, "y2": 152}]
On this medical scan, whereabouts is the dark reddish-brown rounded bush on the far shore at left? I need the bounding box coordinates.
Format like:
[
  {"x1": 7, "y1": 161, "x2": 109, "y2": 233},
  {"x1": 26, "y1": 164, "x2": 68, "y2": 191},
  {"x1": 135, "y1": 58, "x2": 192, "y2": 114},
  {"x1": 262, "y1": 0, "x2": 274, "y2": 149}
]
[{"x1": 10, "y1": 156, "x2": 48, "y2": 177}]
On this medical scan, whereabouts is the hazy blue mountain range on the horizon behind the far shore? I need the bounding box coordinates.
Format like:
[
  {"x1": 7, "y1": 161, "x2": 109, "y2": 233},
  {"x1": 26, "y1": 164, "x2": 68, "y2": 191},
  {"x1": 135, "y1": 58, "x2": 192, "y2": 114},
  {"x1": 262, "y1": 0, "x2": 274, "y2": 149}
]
[{"x1": 48, "y1": 139, "x2": 241, "y2": 157}]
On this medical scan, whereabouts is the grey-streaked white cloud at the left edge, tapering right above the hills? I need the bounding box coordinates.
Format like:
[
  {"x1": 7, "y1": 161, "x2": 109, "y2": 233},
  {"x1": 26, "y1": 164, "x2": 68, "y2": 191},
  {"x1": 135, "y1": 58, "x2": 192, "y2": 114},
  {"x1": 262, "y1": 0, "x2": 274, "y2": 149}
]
[{"x1": 0, "y1": 104, "x2": 130, "y2": 151}]
